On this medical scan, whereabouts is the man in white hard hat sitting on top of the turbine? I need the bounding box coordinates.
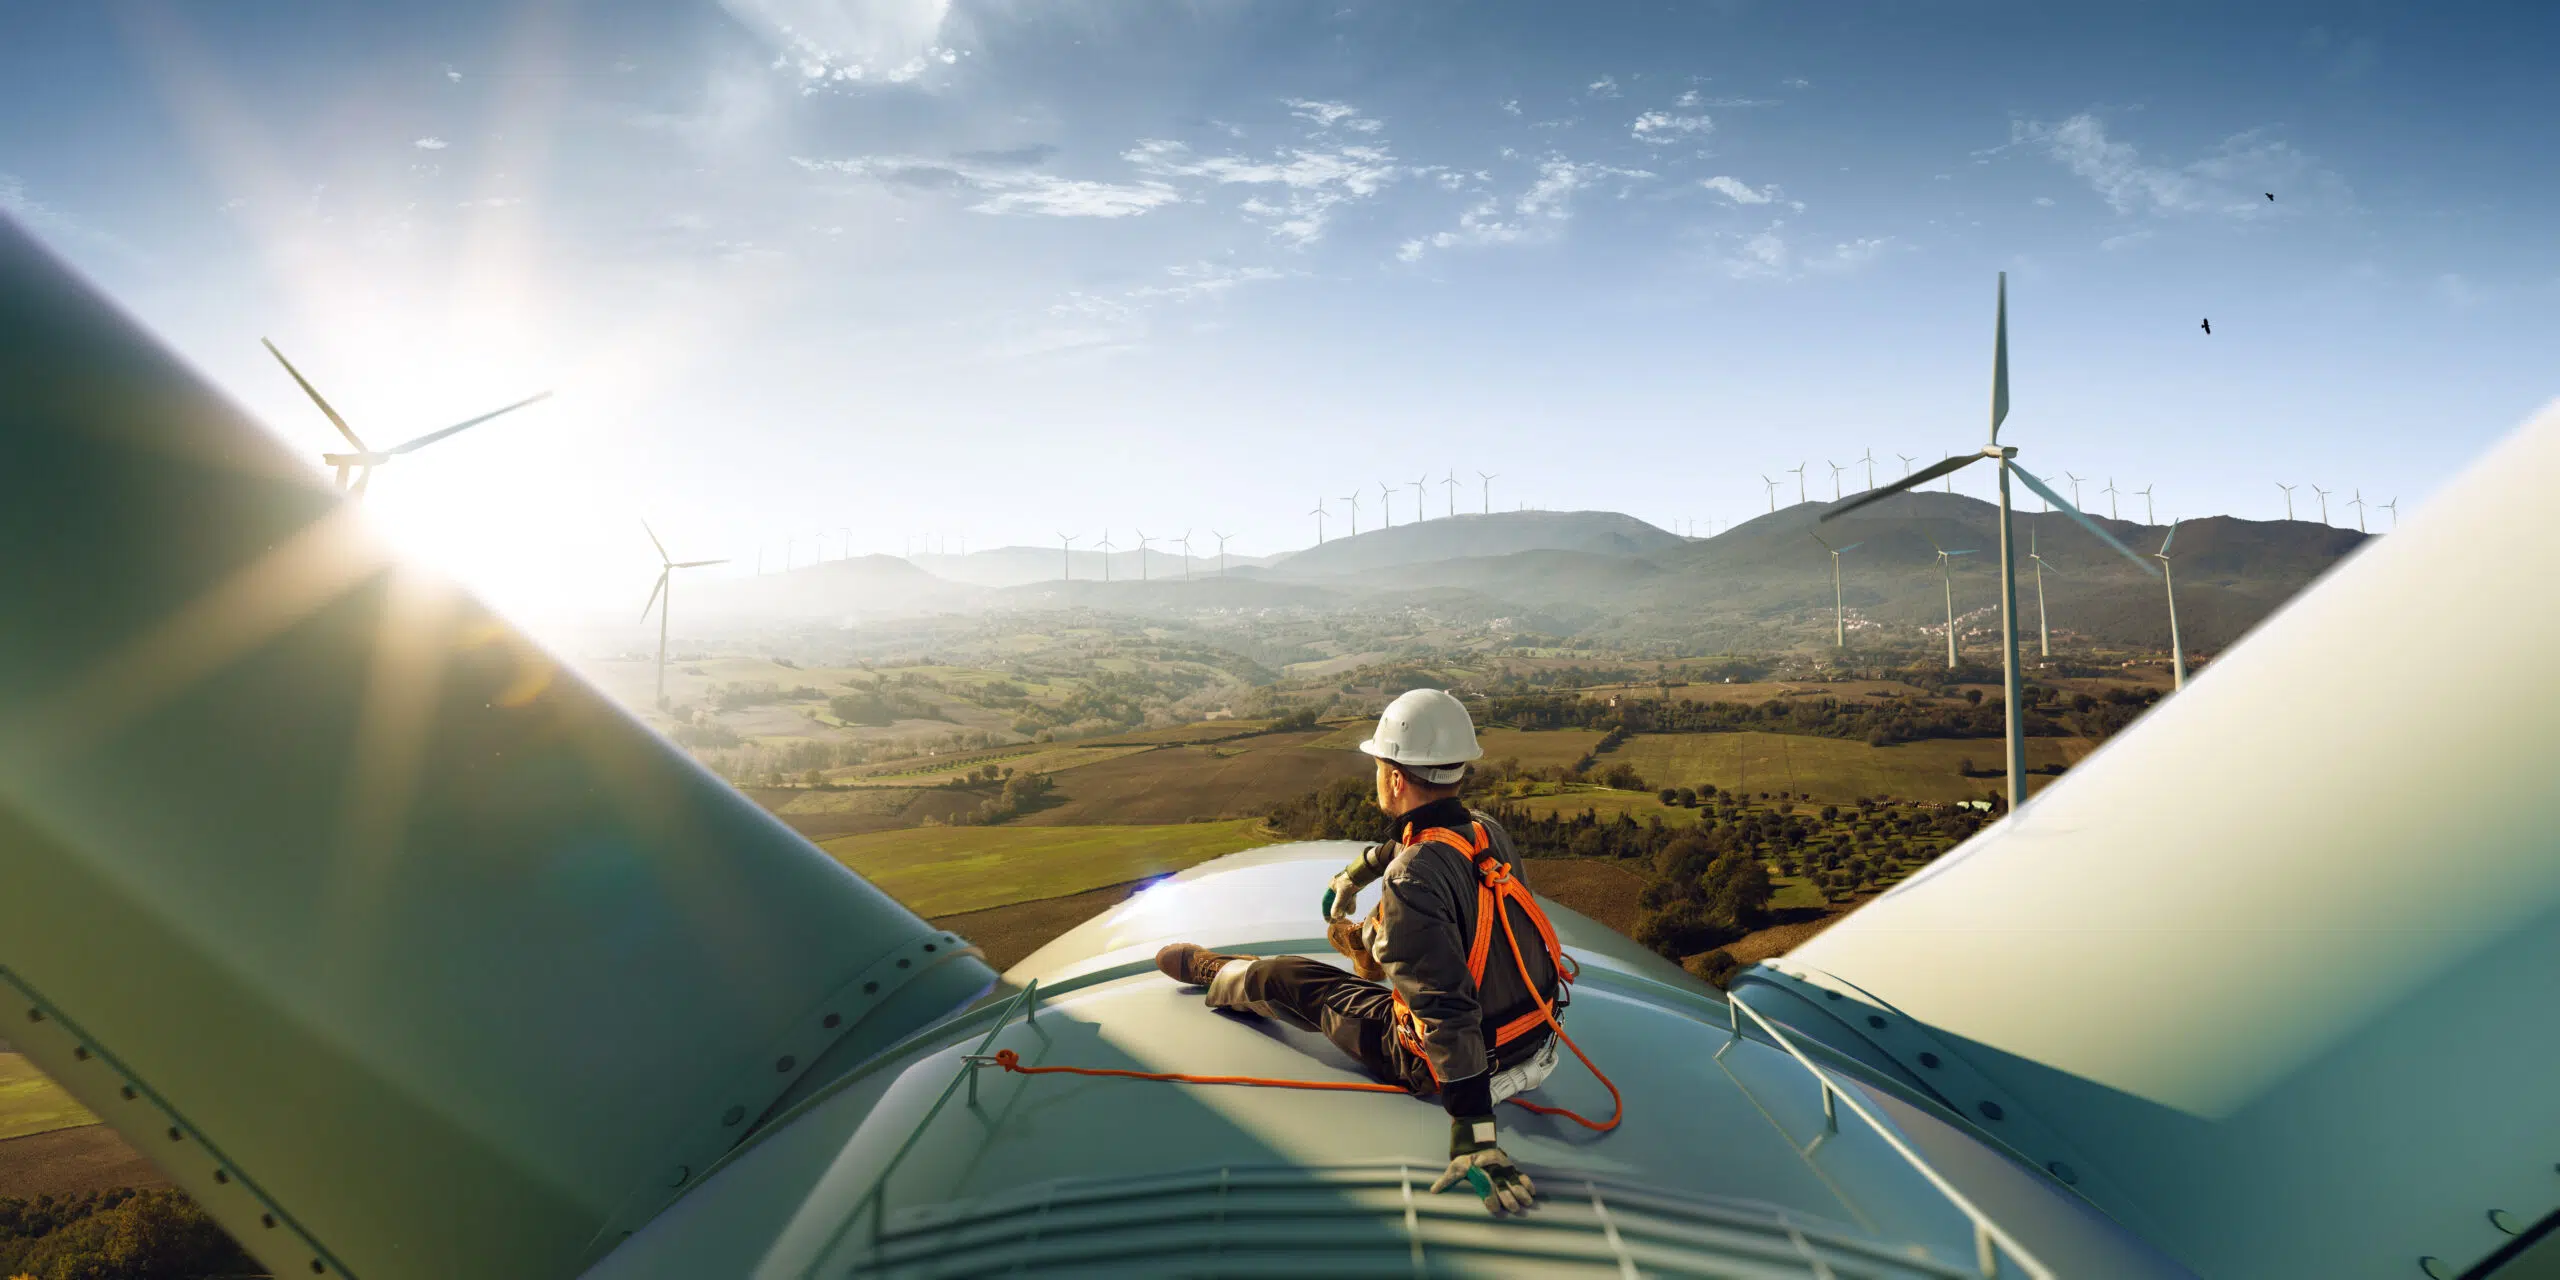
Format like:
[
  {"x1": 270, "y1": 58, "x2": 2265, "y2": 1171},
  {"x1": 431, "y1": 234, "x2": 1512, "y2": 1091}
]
[{"x1": 1155, "y1": 689, "x2": 1562, "y2": 1216}]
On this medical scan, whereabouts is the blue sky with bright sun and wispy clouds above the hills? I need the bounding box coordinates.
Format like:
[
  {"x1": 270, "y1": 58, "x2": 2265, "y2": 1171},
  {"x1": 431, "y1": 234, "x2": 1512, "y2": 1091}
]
[{"x1": 0, "y1": 0, "x2": 2560, "y2": 622}]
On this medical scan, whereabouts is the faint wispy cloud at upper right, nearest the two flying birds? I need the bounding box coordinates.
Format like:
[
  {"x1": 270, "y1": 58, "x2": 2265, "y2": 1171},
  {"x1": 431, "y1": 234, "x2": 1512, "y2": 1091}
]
[{"x1": 1992, "y1": 113, "x2": 2350, "y2": 218}]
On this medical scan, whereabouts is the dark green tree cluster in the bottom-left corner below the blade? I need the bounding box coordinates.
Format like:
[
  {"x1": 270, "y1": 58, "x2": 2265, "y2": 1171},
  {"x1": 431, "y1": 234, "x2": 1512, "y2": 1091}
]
[{"x1": 0, "y1": 1188, "x2": 266, "y2": 1280}]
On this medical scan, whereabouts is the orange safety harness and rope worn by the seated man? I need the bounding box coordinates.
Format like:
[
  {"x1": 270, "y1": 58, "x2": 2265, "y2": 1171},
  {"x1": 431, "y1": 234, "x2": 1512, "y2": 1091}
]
[{"x1": 996, "y1": 822, "x2": 1626, "y2": 1134}]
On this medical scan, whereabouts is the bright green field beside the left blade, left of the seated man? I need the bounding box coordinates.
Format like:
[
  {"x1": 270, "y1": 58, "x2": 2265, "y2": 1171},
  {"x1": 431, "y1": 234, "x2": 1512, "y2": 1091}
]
[{"x1": 819, "y1": 819, "x2": 1272, "y2": 916}]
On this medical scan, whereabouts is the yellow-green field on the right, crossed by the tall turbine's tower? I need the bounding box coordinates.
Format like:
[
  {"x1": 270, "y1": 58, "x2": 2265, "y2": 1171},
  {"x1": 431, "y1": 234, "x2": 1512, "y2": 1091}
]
[{"x1": 1600, "y1": 732, "x2": 2089, "y2": 804}]
